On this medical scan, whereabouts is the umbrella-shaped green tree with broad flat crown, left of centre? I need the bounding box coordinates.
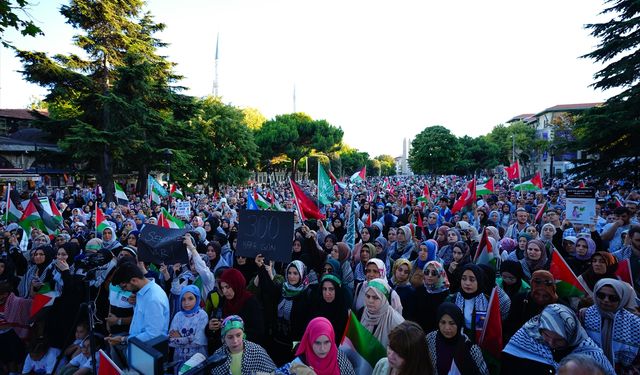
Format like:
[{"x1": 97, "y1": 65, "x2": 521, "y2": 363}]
[{"x1": 255, "y1": 113, "x2": 344, "y2": 178}]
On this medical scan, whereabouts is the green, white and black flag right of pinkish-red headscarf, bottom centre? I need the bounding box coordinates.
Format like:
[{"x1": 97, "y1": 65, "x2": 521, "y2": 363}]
[{"x1": 340, "y1": 311, "x2": 387, "y2": 374}]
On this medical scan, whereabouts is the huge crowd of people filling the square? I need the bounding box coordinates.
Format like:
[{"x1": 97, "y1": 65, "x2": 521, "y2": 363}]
[{"x1": 0, "y1": 176, "x2": 640, "y2": 375}]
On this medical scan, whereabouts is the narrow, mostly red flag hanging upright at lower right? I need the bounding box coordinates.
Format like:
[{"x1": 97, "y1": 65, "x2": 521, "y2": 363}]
[{"x1": 478, "y1": 286, "x2": 503, "y2": 374}]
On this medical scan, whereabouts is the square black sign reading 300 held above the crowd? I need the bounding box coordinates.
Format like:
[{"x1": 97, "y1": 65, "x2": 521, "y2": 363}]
[{"x1": 236, "y1": 210, "x2": 293, "y2": 263}]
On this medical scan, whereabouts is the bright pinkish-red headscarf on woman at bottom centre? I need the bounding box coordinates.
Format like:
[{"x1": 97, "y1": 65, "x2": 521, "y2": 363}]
[{"x1": 296, "y1": 317, "x2": 340, "y2": 375}]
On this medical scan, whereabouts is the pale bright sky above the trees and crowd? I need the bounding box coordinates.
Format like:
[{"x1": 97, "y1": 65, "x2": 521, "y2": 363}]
[{"x1": 0, "y1": 0, "x2": 615, "y2": 157}]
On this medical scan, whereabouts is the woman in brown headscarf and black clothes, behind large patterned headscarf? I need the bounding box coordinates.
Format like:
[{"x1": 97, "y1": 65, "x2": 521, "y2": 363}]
[{"x1": 502, "y1": 270, "x2": 566, "y2": 342}]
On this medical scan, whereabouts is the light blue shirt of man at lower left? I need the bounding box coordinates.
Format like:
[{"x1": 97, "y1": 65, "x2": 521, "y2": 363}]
[{"x1": 129, "y1": 280, "x2": 169, "y2": 341}]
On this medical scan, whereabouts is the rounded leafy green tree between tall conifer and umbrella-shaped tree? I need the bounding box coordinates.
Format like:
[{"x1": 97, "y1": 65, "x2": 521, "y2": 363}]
[{"x1": 190, "y1": 96, "x2": 259, "y2": 189}]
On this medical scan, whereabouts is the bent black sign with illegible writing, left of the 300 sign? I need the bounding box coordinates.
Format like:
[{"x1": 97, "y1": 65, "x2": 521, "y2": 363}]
[{"x1": 137, "y1": 224, "x2": 189, "y2": 265}]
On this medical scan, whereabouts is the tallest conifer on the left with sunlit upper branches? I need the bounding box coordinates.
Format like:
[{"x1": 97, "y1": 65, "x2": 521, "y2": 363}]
[{"x1": 17, "y1": 0, "x2": 171, "y2": 200}]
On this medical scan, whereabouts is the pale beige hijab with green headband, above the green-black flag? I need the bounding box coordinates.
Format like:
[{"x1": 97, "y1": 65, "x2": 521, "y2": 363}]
[{"x1": 360, "y1": 278, "x2": 404, "y2": 347}]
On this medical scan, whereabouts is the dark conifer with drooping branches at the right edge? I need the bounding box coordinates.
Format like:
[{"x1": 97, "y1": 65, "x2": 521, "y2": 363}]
[{"x1": 571, "y1": 0, "x2": 640, "y2": 182}]
